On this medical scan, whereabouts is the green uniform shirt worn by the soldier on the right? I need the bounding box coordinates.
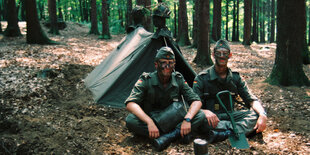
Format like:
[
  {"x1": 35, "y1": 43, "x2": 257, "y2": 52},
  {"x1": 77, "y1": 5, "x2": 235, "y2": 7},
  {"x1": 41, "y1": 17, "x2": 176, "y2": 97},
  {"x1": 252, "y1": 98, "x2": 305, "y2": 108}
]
[{"x1": 193, "y1": 65, "x2": 257, "y2": 113}]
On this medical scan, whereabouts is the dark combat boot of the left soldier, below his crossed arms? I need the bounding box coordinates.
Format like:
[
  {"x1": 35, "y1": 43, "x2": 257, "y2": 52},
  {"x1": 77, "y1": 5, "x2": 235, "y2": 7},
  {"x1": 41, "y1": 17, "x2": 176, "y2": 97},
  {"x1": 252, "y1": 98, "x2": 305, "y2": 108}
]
[{"x1": 153, "y1": 129, "x2": 181, "y2": 151}]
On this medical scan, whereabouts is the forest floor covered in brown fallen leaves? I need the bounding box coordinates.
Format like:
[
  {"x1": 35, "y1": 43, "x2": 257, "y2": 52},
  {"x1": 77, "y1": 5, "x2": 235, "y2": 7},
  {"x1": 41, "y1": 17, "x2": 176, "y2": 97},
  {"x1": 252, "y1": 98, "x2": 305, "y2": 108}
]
[{"x1": 0, "y1": 22, "x2": 310, "y2": 154}]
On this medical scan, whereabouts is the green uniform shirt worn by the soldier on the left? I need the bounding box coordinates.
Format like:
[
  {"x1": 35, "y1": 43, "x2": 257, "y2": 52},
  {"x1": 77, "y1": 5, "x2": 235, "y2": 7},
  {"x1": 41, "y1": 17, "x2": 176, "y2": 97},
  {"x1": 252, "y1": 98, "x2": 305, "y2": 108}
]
[{"x1": 125, "y1": 71, "x2": 200, "y2": 114}]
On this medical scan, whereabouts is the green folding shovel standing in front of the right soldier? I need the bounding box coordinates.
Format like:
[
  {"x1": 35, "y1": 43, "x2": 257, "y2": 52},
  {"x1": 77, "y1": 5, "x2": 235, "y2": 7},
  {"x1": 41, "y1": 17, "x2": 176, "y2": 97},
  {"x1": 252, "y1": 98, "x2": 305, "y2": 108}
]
[{"x1": 216, "y1": 90, "x2": 250, "y2": 149}]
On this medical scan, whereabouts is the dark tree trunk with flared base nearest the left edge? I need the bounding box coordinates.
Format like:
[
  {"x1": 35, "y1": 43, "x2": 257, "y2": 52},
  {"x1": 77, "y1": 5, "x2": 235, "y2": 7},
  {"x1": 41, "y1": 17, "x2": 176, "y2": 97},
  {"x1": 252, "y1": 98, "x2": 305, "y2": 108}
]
[{"x1": 4, "y1": 0, "x2": 22, "y2": 37}]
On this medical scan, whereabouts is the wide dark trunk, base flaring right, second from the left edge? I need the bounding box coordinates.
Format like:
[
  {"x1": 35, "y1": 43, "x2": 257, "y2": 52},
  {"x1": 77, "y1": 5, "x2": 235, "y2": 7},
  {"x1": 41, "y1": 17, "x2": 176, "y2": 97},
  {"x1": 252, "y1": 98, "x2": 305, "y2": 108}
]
[{"x1": 26, "y1": 0, "x2": 56, "y2": 44}]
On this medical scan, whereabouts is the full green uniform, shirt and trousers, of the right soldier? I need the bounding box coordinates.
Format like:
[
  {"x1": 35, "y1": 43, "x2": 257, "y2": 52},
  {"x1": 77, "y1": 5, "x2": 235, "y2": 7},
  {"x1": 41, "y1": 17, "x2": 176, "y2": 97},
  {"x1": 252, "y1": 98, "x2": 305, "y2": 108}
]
[{"x1": 193, "y1": 66, "x2": 258, "y2": 134}]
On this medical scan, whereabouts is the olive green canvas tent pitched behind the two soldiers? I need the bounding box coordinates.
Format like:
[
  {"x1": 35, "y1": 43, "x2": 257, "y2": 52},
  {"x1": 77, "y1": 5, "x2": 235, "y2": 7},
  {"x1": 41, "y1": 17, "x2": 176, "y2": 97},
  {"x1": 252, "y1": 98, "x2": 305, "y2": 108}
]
[{"x1": 85, "y1": 24, "x2": 196, "y2": 108}]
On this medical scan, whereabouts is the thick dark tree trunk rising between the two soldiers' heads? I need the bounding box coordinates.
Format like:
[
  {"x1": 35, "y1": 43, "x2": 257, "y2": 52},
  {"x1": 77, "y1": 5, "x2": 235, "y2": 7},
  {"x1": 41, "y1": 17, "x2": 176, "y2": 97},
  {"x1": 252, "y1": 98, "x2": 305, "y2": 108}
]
[{"x1": 194, "y1": 0, "x2": 213, "y2": 65}]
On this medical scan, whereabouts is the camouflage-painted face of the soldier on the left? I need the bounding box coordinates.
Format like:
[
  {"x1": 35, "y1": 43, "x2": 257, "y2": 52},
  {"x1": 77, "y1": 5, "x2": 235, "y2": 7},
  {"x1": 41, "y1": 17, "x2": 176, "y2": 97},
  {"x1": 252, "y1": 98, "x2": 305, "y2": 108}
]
[{"x1": 155, "y1": 59, "x2": 175, "y2": 77}]
